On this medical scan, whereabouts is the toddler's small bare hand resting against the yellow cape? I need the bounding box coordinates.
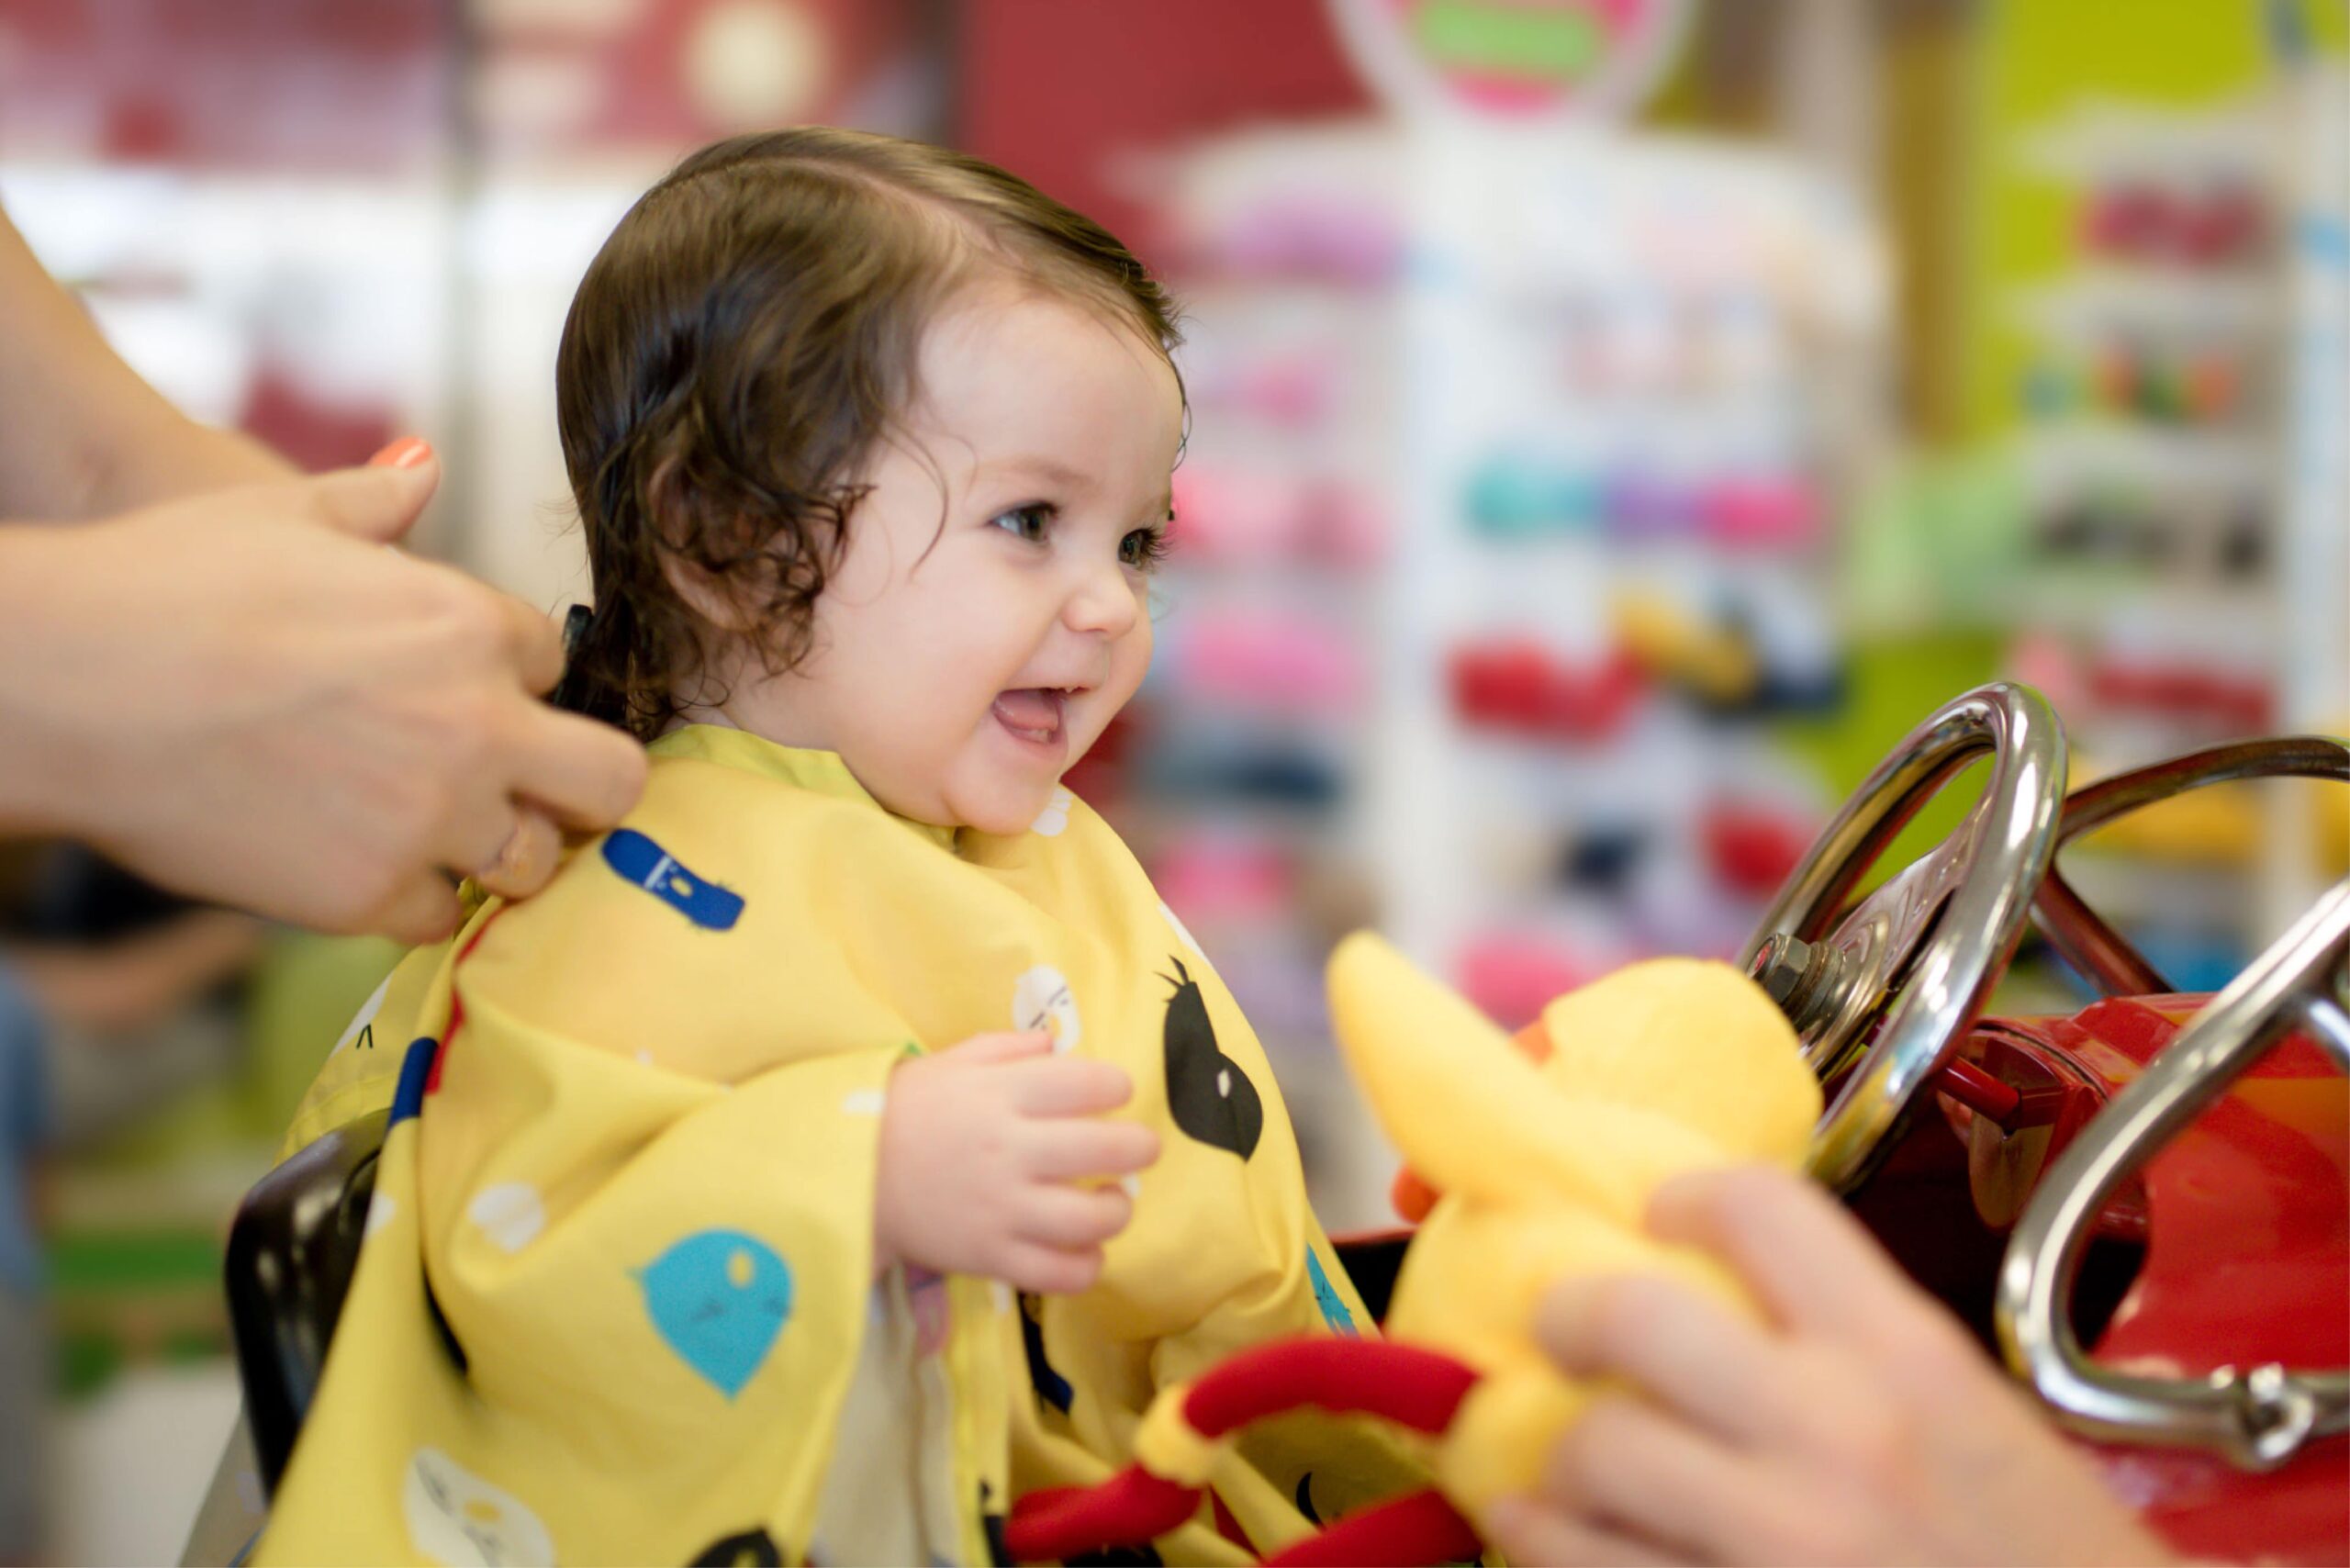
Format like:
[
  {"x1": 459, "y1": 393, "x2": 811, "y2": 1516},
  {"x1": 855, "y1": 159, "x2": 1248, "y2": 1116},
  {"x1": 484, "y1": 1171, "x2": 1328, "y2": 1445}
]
[{"x1": 874, "y1": 1032, "x2": 1158, "y2": 1295}]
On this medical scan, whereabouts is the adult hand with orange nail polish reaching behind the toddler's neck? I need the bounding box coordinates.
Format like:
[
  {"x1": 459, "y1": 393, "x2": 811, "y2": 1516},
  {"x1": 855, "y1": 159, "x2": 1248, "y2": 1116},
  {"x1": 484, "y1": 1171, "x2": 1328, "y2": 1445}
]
[{"x1": 0, "y1": 442, "x2": 643, "y2": 943}]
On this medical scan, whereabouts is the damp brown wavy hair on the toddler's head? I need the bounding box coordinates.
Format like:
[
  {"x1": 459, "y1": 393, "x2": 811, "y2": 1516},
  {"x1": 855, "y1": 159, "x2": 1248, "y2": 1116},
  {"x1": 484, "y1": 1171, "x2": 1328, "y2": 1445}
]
[{"x1": 554, "y1": 127, "x2": 1180, "y2": 741}]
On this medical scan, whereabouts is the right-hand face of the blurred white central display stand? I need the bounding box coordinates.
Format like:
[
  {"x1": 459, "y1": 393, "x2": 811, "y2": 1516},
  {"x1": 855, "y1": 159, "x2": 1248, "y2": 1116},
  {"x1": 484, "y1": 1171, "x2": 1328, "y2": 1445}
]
[{"x1": 1377, "y1": 125, "x2": 1885, "y2": 1023}]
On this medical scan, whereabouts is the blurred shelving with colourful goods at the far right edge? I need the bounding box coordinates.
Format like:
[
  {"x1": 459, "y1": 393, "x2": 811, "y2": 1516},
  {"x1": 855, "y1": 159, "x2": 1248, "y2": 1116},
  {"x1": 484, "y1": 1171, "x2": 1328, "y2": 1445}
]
[{"x1": 2007, "y1": 28, "x2": 2350, "y2": 985}]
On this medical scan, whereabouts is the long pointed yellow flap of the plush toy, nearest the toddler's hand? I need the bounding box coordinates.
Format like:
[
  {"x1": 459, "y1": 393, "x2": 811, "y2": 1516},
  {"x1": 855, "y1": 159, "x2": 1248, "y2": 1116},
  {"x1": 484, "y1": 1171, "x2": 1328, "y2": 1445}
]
[{"x1": 1330, "y1": 931, "x2": 1722, "y2": 1225}]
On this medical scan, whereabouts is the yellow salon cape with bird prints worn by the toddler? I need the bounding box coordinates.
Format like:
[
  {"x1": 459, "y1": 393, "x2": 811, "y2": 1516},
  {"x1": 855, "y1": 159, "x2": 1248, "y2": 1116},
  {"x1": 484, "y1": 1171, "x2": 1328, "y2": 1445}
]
[{"x1": 256, "y1": 726, "x2": 1424, "y2": 1563}]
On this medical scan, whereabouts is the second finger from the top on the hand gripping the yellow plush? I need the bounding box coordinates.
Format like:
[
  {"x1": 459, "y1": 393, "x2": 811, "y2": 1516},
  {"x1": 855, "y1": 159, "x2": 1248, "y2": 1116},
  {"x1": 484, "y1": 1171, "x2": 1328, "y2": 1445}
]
[{"x1": 1535, "y1": 1274, "x2": 1805, "y2": 1441}]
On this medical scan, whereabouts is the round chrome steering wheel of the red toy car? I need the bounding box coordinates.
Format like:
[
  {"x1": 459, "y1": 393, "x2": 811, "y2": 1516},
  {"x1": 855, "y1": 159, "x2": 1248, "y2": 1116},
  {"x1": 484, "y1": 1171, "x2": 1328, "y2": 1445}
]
[{"x1": 1739, "y1": 682, "x2": 2065, "y2": 1192}]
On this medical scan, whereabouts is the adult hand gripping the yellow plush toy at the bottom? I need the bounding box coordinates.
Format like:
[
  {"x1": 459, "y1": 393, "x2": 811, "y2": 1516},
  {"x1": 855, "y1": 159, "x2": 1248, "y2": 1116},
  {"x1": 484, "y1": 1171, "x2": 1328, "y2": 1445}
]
[{"x1": 1487, "y1": 1169, "x2": 2177, "y2": 1563}]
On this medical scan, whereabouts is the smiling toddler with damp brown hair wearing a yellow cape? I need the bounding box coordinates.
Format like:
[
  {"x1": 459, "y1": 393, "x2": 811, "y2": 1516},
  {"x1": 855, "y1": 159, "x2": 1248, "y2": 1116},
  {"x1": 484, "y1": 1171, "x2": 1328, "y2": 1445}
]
[{"x1": 256, "y1": 129, "x2": 1419, "y2": 1563}]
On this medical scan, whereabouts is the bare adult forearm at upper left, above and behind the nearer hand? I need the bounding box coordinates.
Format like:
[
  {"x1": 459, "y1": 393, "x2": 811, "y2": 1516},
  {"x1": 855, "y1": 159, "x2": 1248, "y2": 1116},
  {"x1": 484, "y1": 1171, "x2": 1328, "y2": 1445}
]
[{"x1": 0, "y1": 199, "x2": 291, "y2": 520}]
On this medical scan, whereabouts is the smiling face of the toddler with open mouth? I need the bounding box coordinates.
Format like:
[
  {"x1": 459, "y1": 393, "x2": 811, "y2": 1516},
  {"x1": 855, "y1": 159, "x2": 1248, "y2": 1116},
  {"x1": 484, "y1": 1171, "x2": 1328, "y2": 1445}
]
[{"x1": 695, "y1": 289, "x2": 1182, "y2": 834}]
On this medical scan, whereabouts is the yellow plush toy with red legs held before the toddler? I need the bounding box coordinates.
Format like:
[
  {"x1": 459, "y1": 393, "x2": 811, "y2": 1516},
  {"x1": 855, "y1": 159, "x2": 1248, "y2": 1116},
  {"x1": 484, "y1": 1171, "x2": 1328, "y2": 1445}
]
[{"x1": 1008, "y1": 934, "x2": 1821, "y2": 1563}]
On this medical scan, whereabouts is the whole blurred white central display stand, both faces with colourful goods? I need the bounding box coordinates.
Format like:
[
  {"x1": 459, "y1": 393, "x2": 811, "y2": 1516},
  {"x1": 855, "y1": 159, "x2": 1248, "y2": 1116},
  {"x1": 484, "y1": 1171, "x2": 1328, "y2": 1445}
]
[{"x1": 1130, "y1": 122, "x2": 1883, "y2": 1189}]
